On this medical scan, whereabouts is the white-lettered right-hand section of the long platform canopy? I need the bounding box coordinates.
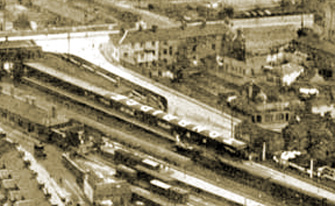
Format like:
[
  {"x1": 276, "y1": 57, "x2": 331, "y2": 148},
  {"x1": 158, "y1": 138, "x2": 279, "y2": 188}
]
[{"x1": 110, "y1": 92, "x2": 248, "y2": 154}]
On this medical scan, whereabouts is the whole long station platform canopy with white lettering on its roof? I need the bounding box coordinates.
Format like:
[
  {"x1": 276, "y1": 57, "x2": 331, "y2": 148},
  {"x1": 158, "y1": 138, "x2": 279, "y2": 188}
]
[{"x1": 22, "y1": 56, "x2": 248, "y2": 159}]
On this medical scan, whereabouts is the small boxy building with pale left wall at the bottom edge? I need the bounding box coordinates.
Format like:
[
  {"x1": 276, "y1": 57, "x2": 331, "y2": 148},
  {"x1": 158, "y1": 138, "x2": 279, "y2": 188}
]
[{"x1": 83, "y1": 172, "x2": 131, "y2": 206}]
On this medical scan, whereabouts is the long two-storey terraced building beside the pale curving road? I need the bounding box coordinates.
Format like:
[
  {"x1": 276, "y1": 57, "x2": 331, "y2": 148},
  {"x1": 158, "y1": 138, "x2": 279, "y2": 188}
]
[{"x1": 110, "y1": 22, "x2": 239, "y2": 67}]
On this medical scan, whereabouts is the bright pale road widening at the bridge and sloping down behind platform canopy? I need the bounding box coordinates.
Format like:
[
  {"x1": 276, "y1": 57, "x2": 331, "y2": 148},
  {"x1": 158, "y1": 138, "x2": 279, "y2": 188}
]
[{"x1": 0, "y1": 31, "x2": 240, "y2": 136}]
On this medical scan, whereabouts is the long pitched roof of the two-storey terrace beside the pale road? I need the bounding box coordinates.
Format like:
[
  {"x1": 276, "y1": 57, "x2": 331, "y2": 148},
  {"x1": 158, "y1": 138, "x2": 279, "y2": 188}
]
[{"x1": 110, "y1": 24, "x2": 229, "y2": 44}]
